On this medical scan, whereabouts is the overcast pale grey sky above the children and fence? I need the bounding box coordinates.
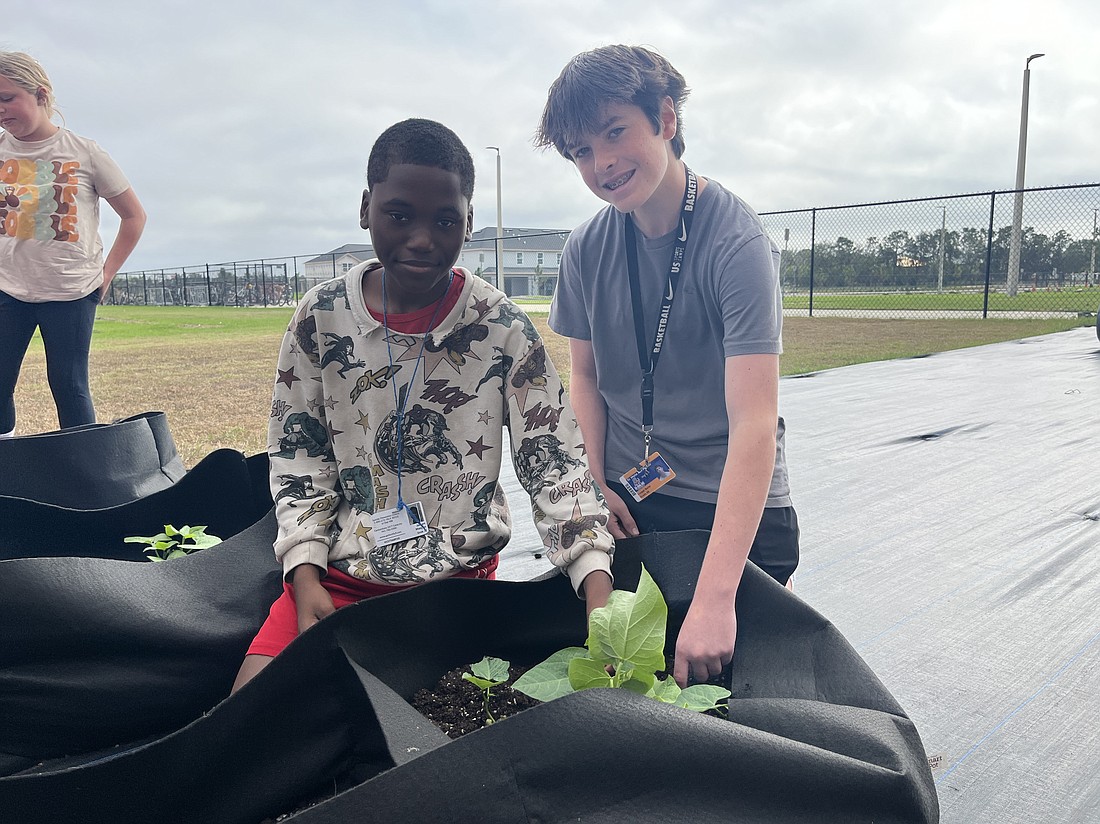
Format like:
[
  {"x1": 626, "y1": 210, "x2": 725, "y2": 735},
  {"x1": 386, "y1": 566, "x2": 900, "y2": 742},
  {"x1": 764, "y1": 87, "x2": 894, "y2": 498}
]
[{"x1": 0, "y1": 0, "x2": 1100, "y2": 270}]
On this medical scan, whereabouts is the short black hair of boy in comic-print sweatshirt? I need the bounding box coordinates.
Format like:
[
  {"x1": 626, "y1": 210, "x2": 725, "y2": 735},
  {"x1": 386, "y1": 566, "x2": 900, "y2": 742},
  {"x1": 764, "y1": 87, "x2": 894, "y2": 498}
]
[{"x1": 366, "y1": 118, "x2": 474, "y2": 200}]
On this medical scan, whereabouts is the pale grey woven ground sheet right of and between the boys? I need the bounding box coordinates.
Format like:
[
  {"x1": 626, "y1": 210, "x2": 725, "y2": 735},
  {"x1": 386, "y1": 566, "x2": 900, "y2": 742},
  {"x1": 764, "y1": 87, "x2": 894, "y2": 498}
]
[{"x1": 502, "y1": 328, "x2": 1100, "y2": 824}]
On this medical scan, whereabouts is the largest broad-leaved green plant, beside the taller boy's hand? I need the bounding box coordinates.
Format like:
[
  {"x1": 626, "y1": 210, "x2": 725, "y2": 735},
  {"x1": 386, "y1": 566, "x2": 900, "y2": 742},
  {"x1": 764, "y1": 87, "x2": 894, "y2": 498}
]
[{"x1": 513, "y1": 567, "x2": 730, "y2": 713}]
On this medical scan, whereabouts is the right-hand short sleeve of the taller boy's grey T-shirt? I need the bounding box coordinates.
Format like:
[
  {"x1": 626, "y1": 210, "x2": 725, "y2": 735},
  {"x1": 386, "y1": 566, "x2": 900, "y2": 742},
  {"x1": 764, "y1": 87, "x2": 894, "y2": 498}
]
[{"x1": 716, "y1": 232, "x2": 783, "y2": 358}]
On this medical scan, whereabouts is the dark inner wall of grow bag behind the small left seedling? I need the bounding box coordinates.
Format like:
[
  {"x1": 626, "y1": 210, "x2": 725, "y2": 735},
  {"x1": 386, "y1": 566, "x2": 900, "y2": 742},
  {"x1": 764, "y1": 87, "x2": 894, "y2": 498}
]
[{"x1": 0, "y1": 449, "x2": 272, "y2": 562}]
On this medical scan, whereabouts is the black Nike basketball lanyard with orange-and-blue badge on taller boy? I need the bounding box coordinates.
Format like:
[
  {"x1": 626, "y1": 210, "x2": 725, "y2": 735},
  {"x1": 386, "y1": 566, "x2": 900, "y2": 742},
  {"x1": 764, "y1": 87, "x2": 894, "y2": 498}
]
[{"x1": 620, "y1": 166, "x2": 699, "y2": 475}]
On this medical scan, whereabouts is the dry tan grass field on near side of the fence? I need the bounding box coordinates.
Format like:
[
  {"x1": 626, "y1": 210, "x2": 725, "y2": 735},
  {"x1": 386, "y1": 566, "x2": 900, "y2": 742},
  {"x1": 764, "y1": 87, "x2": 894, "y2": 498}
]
[{"x1": 15, "y1": 306, "x2": 1092, "y2": 466}]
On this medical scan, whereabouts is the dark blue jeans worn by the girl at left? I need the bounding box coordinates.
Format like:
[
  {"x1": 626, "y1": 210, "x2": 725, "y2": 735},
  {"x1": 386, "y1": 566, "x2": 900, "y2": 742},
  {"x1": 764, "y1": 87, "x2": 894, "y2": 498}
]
[{"x1": 0, "y1": 292, "x2": 99, "y2": 433}]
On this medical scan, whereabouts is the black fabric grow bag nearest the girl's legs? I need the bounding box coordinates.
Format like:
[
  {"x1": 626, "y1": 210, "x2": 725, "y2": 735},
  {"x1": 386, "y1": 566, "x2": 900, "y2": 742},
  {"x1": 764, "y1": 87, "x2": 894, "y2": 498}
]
[{"x1": 0, "y1": 411, "x2": 186, "y2": 509}]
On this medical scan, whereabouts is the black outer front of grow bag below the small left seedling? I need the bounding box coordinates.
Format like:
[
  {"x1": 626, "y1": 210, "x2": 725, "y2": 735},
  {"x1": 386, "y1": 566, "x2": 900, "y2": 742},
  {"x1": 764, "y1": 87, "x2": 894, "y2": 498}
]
[{"x1": 0, "y1": 510, "x2": 282, "y2": 770}]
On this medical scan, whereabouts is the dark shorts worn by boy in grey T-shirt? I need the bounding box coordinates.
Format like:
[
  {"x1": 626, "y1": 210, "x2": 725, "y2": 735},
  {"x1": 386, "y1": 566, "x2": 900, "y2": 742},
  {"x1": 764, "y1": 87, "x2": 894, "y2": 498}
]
[{"x1": 606, "y1": 481, "x2": 799, "y2": 584}]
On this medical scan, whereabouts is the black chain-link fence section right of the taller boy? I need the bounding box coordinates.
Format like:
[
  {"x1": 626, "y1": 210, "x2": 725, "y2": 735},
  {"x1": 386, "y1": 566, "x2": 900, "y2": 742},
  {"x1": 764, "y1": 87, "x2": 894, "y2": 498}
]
[{"x1": 760, "y1": 184, "x2": 1100, "y2": 318}]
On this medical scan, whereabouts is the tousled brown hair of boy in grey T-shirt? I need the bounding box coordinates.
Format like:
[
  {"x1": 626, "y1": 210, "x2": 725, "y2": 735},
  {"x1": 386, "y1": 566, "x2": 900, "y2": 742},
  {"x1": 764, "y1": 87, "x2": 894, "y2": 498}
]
[{"x1": 535, "y1": 45, "x2": 690, "y2": 160}]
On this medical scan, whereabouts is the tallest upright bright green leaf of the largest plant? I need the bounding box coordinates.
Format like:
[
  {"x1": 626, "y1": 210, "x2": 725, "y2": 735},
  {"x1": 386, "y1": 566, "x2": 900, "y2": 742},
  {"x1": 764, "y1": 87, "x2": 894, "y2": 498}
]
[{"x1": 587, "y1": 567, "x2": 669, "y2": 672}]
